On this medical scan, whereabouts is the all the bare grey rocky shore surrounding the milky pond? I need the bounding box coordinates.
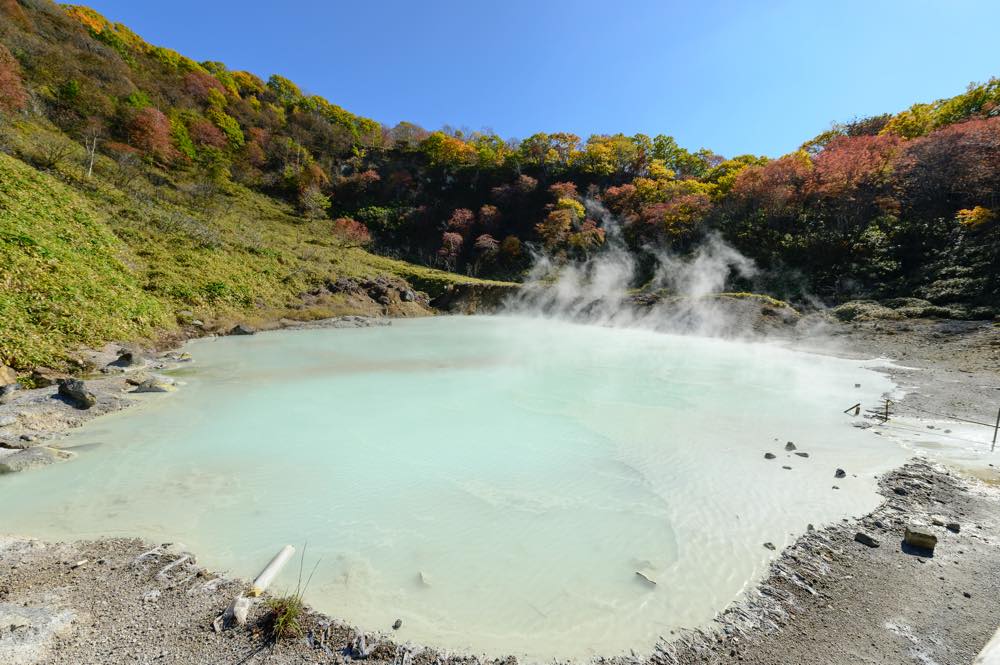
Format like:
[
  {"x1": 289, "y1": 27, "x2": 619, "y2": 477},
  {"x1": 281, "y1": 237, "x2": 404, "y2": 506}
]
[{"x1": 0, "y1": 317, "x2": 1000, "y2": 665}]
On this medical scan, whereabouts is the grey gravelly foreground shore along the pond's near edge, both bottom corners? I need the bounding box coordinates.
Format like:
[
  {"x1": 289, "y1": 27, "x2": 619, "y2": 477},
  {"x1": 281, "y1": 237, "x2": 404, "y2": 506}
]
[{"x1": 0, "y1": 462, "x2": 1000, "y2": 665}]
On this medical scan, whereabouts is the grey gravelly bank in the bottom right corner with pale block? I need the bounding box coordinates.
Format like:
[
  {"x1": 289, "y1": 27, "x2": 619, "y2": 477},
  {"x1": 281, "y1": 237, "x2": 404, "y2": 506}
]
[{"x1": 649, "y1": 462, "x2": 1000, "y2": 665}]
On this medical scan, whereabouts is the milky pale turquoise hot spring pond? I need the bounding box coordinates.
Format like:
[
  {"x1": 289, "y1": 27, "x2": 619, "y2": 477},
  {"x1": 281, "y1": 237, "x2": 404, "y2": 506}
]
[{"x1": 0, "y1": 317, "x2": 906, "y2": 660}]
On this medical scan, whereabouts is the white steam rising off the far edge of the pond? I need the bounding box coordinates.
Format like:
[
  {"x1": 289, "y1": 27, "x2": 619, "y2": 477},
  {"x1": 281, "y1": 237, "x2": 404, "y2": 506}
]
[{"x1": 505, "y1": 199, "x2": 757, "y2": 336}]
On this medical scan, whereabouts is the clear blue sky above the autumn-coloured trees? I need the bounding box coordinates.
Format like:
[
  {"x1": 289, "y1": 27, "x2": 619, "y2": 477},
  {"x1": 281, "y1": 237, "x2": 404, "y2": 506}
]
[{"x1": 80, "y1": 0, "x2": 1000, "y2": 156}]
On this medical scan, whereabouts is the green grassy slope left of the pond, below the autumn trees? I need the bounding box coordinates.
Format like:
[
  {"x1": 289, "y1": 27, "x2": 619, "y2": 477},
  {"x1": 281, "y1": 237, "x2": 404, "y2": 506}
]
[{"x1": 0, "y1": 122, "x2": 500, "y2": 368}]
